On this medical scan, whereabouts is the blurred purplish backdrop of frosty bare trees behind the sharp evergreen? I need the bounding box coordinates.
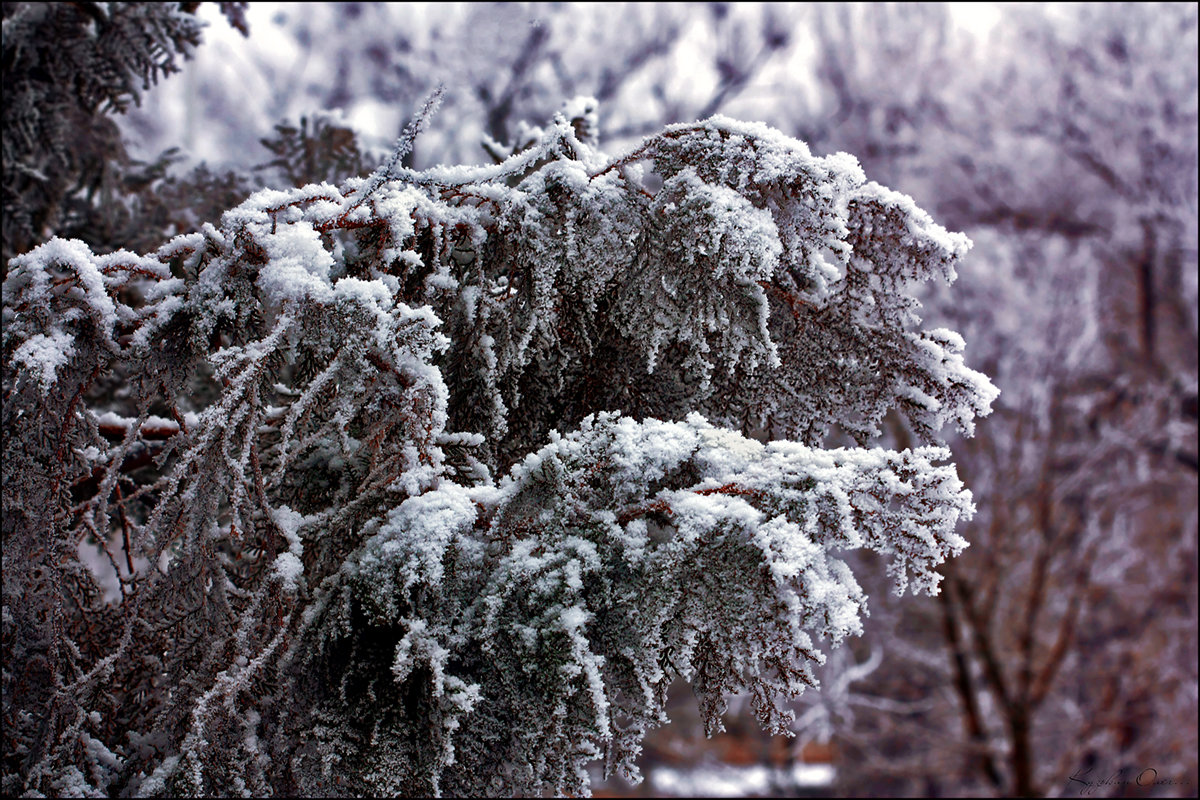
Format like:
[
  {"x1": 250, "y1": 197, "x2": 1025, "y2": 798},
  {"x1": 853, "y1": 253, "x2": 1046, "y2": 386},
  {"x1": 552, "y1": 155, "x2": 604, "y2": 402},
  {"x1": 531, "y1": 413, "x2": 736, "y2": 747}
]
[{"x1": 119, "y1": 2, "x2": 1198, "y2": 796}]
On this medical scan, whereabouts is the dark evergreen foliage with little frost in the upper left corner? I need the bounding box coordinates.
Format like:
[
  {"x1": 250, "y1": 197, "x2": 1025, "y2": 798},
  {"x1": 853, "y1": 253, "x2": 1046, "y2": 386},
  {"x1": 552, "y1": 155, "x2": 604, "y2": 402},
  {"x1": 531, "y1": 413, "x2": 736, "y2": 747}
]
[{"x1": 0, "y1": 2, "x2": 248, "y2": 263}]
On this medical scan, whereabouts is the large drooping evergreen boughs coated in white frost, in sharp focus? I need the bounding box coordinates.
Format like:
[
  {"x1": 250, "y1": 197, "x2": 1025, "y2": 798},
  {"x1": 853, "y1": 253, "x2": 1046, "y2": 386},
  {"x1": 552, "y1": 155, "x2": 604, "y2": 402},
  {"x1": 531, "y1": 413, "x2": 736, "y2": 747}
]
[{"x1": 2, "y1": 97, "x2": 996, "y2": 795}]
